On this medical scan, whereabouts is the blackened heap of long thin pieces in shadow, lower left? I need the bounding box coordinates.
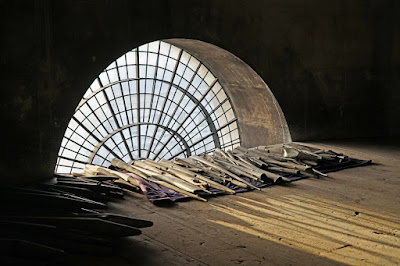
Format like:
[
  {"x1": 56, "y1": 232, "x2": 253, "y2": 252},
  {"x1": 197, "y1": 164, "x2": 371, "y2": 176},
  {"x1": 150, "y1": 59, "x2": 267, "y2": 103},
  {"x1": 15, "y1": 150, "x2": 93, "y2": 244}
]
[{"x1": 0, "y1": 175, "x2": 153, "y2": 265}]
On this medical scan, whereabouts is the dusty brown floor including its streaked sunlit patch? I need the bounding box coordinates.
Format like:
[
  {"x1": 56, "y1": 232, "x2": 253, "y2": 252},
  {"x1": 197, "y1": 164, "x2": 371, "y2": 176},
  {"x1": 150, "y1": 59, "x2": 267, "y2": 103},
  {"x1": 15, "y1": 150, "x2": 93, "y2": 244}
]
[{"x1": 81, "y1": 140, "x2": 400, "y2": 265}]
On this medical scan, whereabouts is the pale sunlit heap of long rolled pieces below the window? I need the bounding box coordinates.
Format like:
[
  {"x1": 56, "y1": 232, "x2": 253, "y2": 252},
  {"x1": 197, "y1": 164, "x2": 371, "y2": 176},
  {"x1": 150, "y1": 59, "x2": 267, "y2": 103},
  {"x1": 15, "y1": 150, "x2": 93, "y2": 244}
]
[{"x1": 77, "y1": 143, "x2": 347, "y2": 201}]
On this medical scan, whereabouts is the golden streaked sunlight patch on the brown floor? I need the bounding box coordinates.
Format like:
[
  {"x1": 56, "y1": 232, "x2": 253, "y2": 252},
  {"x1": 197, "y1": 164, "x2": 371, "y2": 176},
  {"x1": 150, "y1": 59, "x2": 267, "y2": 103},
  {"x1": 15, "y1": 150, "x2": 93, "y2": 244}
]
[{"x1": 208, "y1": 195, "x2": 400, "y2": 265}]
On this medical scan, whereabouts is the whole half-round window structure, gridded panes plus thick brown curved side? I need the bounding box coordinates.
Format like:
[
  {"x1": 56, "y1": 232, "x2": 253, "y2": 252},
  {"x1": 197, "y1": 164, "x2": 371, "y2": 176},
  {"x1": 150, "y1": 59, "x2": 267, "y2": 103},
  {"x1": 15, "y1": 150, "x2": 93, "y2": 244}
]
[{"x1": 55, "y1": 39, "x2": 291, "y2": 173}]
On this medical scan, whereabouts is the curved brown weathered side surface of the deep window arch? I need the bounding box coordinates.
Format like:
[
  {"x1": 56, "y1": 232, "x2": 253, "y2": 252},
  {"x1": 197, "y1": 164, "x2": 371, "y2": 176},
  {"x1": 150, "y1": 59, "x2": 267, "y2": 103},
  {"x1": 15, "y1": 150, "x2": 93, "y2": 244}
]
[{"x1": 163, "y1": 39, "x2": 292, "y2": 147}]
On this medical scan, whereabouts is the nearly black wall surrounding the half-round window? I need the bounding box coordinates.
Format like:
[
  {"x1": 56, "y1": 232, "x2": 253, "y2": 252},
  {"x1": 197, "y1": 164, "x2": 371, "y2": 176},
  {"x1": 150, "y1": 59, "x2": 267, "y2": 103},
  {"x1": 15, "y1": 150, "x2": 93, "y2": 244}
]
[{"x1": 0, "y1": 0, "x2": 400, "y2": 183}]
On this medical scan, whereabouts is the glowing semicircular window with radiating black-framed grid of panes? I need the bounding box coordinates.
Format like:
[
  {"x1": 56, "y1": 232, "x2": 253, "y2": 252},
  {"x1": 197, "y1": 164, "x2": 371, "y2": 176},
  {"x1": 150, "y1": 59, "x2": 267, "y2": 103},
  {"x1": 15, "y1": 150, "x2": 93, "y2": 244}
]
[{"x1": 55, "y1": 41, "x2": 240, "y2": 173}]
